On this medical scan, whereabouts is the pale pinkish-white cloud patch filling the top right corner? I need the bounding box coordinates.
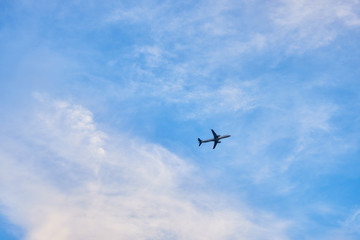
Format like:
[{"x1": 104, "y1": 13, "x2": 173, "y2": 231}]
[{"x1": 271, "y1": 0, "x2": 360, "y2": 52}]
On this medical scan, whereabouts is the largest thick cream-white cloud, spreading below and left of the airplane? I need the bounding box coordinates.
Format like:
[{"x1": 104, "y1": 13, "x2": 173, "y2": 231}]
[{"x1": 0, "y1": 98, "x2": 288, "y2": 240}]
